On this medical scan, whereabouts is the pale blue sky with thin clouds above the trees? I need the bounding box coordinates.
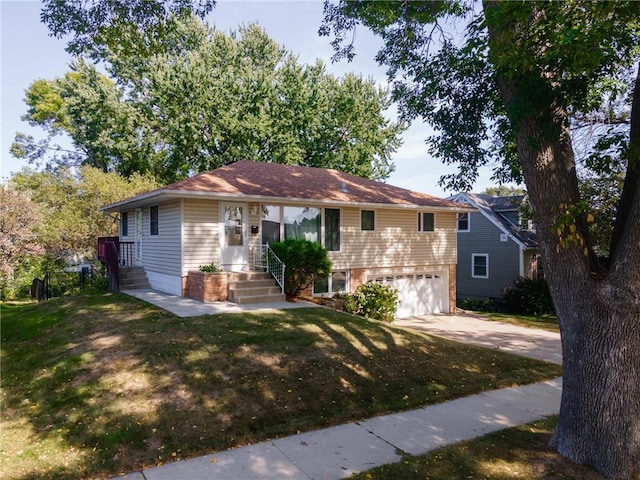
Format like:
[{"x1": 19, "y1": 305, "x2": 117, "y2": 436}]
[{"x1": 0, "y1": 0, "x2": 502, "y2": 197}]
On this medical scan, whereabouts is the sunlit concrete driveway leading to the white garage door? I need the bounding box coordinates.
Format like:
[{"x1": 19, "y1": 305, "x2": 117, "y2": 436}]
[{"x1": 394, "y1": 314, "x2": 562, "y2": 364}]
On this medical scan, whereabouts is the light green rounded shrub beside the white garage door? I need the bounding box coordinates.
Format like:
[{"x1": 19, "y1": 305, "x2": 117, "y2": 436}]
[{"x1": 344, "y1": 282, "x2": 398, "y2": 322}]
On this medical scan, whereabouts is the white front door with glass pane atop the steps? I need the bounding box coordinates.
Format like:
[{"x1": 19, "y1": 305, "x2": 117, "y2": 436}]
[{"x1": 220, "y1": 203, "x2": 248, "y2": 271}]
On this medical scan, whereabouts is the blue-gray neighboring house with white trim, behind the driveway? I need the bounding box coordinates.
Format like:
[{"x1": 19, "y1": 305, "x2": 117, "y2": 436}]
[{"x1": 449, "y1": 193, "x2": 542, "y2": 299}]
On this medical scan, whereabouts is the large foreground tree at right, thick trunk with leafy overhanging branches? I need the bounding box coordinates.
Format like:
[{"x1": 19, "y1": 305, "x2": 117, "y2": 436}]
[{"x1": 321, "y1": 0, "x2": 640, "y2": 478}]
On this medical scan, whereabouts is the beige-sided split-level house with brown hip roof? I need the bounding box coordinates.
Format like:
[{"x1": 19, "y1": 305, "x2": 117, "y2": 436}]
[{"x1": 102, "y1": 160, "x2": 472, "y2": 316}]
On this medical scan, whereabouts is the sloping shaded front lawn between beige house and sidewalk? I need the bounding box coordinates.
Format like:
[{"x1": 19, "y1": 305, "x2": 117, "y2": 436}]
[{"x1": 0, "y1": 294, "x2": 560, "y2": 480}]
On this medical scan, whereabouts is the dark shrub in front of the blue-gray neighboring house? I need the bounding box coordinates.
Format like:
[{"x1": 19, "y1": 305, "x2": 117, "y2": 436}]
[{"x1": 501, "y1": 277, "x2": 555, "y2": 315}]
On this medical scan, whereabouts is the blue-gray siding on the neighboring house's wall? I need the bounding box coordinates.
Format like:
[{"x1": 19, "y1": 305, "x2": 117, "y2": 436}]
[{"x1": 456, "y1": 212, "x2": 520, "y2": 298}]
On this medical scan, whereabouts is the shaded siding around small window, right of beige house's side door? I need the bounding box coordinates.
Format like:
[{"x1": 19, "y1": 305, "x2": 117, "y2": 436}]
[{"x1": 142, "y1": 200, "x2": 182, "y2": 276}]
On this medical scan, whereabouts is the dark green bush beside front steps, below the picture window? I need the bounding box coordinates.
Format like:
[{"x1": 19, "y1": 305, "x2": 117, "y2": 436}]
[{"x1": 270, "y1": 238, "x2": 331, "y2": 297}]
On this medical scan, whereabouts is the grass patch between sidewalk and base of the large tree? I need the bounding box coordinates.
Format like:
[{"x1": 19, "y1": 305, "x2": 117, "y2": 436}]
[{"x1": 351, "y1": 417, "x2": 605, "y2": 480}]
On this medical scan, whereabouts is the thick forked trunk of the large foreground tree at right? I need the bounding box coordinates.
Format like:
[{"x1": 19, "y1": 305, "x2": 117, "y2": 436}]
[{"x1": 485, "y1": 2, "x2": 640, "y2": 479}]
